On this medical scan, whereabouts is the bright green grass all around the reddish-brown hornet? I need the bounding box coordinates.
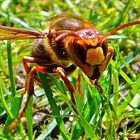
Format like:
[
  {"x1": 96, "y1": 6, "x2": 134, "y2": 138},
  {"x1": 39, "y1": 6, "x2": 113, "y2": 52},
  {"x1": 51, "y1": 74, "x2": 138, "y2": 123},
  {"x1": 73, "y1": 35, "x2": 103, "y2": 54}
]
[{"x1": 0, "y1": 0, "x2": 140, "y2": 140}]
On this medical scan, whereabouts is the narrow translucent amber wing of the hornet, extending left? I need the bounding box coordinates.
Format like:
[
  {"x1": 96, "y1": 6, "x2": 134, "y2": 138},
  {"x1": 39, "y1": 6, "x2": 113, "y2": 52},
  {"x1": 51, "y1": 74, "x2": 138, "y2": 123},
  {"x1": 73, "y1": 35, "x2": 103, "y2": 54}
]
[{"x1": 0, "y1": 25, "x2": 45, "y2": 40}]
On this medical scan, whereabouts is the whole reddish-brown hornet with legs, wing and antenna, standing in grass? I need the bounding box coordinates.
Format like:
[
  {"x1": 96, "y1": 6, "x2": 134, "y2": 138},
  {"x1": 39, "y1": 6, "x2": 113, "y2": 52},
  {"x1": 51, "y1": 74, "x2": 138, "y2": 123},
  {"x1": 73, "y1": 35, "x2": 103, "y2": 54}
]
[{"x1": 0, "y1": 15, "x2": 140, "y2": 129}]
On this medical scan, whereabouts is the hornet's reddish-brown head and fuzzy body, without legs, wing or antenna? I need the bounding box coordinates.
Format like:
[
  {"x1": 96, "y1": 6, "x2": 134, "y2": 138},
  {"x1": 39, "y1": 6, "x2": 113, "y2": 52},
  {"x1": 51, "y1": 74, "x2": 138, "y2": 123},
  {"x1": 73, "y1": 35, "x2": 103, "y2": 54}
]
[{"x1": 32, "y1": 16, "x2": 111, "y2": 80}]
